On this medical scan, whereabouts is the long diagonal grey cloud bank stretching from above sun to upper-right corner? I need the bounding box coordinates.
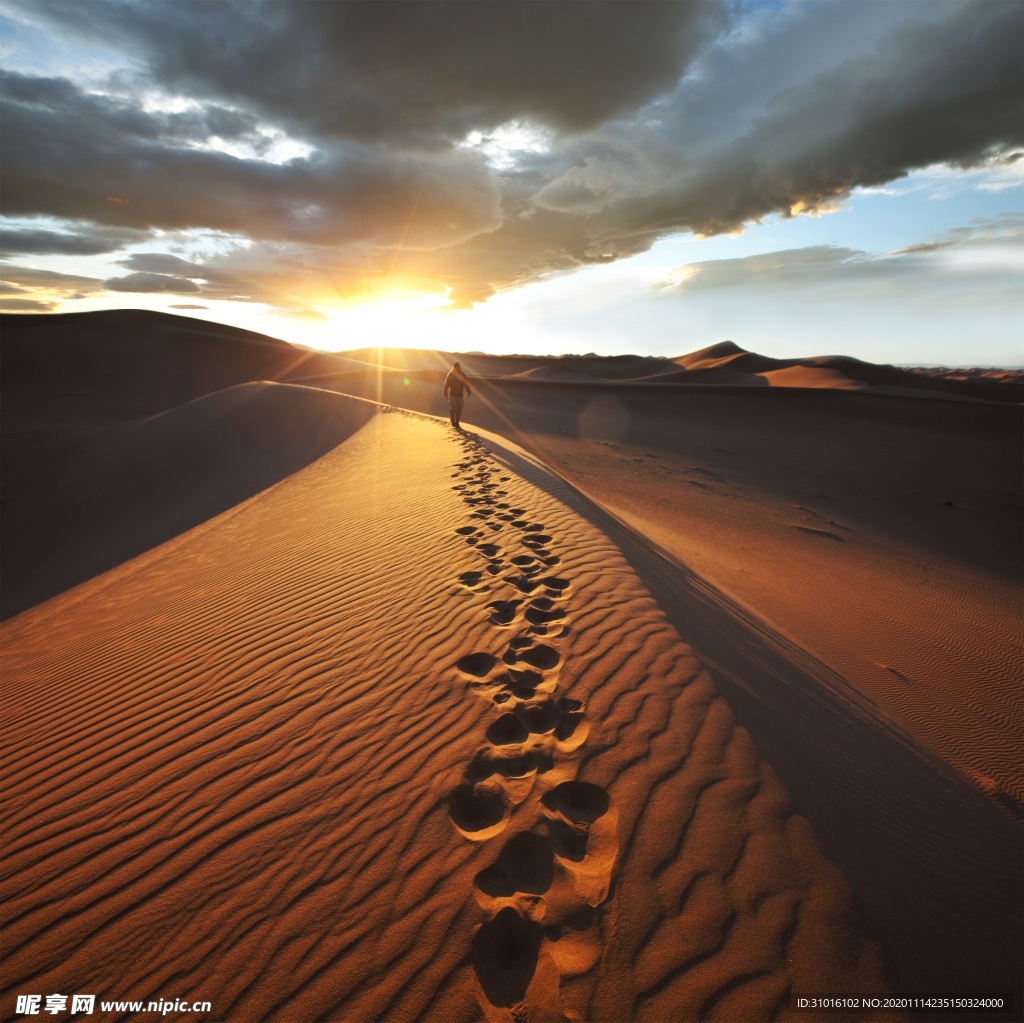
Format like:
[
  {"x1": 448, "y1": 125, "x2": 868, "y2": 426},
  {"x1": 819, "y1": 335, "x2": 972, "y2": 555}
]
[{"x1": 352, "y1": 2, "x2": 1024, "y2": 299}]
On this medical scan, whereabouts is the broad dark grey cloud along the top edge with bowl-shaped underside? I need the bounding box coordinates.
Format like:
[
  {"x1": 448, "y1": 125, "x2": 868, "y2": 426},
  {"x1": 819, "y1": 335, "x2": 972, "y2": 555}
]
[{"x1": 9, "y1": 0, "x2": 725, "y2": 146}]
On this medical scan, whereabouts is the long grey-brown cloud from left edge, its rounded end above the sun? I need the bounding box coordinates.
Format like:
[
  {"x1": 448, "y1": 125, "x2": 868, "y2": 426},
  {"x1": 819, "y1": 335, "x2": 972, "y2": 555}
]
[{"x1": 0, "y1": 73, "x2": 500, "y2": 253}]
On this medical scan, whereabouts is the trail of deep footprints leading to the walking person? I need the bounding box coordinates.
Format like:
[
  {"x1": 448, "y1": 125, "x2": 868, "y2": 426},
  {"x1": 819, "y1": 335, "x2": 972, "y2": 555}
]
[{"x1": 449, "y1": 436, "x2": 618, "y2": 1023}]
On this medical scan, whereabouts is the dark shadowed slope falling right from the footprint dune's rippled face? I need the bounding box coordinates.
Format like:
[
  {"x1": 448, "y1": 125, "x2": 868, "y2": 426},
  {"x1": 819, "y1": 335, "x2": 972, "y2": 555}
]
[{"x1": 479, "y1": 436, "x2": 1024, "y2": 1003}]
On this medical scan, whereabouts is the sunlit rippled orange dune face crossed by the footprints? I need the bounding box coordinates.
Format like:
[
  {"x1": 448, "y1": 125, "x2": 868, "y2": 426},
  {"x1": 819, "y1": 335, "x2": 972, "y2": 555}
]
[{"x1": 2, "y1": 412, "x2": 885, "y2": 1023}]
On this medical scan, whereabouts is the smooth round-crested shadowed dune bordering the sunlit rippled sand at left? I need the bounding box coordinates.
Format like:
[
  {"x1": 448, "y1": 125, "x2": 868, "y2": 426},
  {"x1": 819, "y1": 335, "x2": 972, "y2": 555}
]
[{"x1": 3, "y1": 382, "x2": 373, "y2": 616}]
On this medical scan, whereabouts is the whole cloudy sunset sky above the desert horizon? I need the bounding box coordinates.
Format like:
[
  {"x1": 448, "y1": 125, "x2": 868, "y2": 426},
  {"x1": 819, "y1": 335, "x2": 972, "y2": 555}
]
[{"x1": 0, "y1": 0, "x2": 1024, "y2": 367}]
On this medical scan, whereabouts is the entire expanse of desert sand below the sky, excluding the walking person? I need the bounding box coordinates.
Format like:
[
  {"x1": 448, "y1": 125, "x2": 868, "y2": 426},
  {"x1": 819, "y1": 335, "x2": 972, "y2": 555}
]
[{"x1": 0, "y1": 311, "x2": 1024, "y2": 1023}]
